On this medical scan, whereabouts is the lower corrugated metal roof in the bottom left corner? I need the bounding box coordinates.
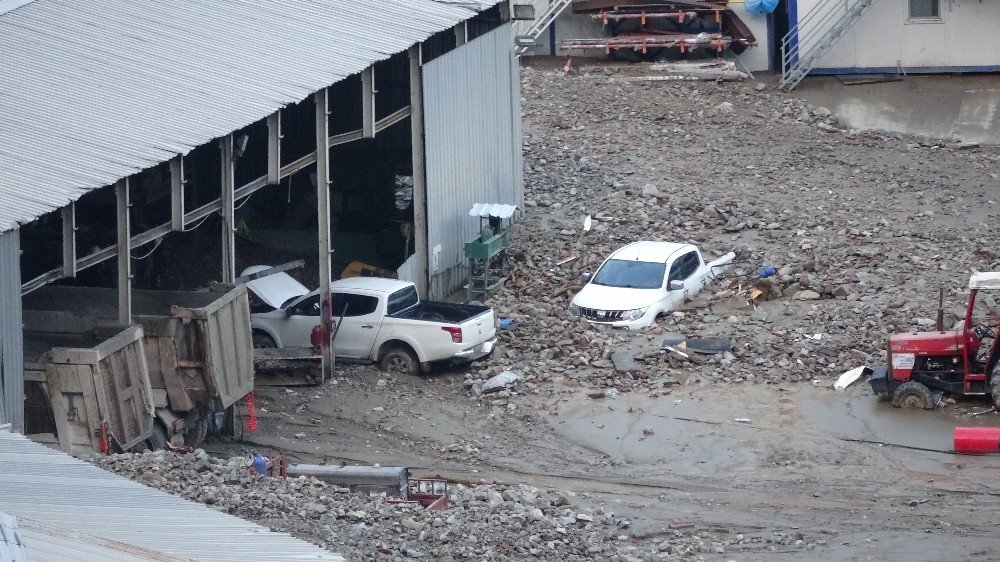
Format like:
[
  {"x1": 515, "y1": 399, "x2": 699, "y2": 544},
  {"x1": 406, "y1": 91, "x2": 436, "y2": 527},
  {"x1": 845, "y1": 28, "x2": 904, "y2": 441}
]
[{"x1": 0, "y1": 431, "x2": 343, "y2": 562}]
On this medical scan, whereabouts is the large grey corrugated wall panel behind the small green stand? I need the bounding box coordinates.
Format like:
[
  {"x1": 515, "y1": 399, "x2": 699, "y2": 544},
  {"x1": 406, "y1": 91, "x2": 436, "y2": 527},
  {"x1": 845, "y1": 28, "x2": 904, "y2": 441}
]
[{"x1": 424, "y1": 24, "x2": 524, "y2": 299}]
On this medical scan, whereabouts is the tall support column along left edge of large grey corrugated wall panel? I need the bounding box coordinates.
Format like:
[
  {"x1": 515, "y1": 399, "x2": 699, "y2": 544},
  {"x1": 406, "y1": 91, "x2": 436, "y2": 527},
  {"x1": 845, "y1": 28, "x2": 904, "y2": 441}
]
[{"x1": 409, "y1": 44, "x2": 429, "y2": 297}]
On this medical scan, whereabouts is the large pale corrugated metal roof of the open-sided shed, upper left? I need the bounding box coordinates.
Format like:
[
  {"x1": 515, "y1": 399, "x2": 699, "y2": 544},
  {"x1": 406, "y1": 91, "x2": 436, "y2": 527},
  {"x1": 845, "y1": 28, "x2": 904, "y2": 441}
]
[{"x1": 0, "y1": 0, "x2": 497, "y2": 232}]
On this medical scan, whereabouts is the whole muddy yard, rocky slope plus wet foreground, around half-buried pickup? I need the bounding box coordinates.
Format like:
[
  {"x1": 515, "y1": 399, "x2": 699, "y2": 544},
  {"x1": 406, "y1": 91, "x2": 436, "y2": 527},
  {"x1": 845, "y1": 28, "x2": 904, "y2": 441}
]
[{"x1": 206, "y1": 59, "x2": 1000, "y2": 560}]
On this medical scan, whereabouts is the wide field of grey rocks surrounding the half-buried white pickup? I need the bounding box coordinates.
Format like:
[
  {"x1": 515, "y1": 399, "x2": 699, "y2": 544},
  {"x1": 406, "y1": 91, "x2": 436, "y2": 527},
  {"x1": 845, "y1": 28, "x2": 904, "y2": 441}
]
[{"x1": 466, "y1": 67, "x2": 1000, "y2": 398}]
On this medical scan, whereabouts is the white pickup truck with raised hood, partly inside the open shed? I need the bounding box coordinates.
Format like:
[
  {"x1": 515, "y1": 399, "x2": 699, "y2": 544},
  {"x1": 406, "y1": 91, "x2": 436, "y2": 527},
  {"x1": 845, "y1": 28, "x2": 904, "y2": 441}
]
[{"x1": 243, "y1": 266, "x2": 497, "y2": 374}]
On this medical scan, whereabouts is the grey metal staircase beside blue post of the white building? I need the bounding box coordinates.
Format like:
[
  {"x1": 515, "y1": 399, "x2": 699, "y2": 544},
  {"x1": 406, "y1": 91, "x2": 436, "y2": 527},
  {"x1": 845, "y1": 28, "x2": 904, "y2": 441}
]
[{"x1": 778, "y1": 0, "x2": 874, "y2": 90}]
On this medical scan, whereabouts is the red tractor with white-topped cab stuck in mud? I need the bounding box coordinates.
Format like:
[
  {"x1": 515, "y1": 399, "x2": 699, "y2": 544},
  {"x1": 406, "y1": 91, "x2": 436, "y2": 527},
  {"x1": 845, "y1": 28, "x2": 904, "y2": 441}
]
[{"x1": 869, "y1": 272, "x2": 1000, "y2": 410}]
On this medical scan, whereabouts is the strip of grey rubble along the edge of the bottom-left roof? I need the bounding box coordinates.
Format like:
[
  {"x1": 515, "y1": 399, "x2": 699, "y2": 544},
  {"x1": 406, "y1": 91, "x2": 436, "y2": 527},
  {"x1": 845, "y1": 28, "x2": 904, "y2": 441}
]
[{"x1": 90, "y1": 449, "x2": 772, "y2": 561}]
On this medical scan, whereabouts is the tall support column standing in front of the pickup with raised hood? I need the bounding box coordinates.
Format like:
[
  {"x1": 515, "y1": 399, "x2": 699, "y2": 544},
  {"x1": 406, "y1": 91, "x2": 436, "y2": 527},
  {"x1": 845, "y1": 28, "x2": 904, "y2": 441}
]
[{"x1": 314, "y1": 88, "x2": 335, "y2": 381}]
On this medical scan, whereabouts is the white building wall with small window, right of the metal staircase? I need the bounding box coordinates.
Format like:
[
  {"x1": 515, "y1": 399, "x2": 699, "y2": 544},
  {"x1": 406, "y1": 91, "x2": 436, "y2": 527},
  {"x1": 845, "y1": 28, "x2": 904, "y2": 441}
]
[{"x1": 793, "y1": 0, "x2": 1000, "y2": 73}]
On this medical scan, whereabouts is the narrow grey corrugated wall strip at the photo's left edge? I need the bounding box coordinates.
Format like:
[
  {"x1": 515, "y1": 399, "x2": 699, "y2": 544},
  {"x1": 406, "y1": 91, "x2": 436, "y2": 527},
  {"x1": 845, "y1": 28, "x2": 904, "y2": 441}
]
[{"x1": 0, "y1": 230, "x2": 24, "y2": 424}]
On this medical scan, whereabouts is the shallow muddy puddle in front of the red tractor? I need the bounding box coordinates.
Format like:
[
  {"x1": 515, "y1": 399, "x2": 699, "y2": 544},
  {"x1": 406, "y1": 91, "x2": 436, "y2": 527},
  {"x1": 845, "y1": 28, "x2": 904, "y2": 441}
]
[{"x1": 550, "y1": 383, "x2": 1000, "y2": 476}]
